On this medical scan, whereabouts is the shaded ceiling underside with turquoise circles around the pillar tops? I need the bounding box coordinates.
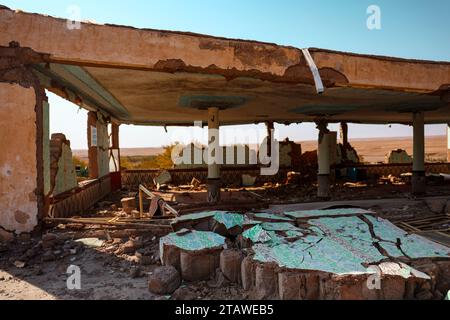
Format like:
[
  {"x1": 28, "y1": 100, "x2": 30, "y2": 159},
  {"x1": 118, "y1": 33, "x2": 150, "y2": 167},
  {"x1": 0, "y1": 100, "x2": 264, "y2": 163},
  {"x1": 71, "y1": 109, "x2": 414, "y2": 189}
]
[{"x1": 36, "y1": 64, "x2": 450, "y2": 125}]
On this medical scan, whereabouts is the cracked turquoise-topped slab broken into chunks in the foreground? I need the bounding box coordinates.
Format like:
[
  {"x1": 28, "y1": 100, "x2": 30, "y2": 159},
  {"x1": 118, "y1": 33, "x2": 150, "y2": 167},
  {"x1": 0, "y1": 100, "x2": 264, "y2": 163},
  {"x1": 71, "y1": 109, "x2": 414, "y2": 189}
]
[{"x1": 156, "y1": 208, "x2": 450, "y2": 299}]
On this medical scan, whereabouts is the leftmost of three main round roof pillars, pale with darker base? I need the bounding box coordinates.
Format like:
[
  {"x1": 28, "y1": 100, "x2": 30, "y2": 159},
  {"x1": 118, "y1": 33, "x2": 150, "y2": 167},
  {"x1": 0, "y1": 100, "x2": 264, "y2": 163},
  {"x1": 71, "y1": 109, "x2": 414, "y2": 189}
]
[{"x1": 207, "y1": 108, "x2": 221, "y2": 203}]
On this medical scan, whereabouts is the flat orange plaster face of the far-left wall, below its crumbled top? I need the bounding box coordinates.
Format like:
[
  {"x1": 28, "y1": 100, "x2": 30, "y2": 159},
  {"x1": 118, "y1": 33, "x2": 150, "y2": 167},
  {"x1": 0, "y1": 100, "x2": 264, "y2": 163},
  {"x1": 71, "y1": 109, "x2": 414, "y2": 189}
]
[{"x1": 0, "y1": 83, "x2": 38, "y2": 234}]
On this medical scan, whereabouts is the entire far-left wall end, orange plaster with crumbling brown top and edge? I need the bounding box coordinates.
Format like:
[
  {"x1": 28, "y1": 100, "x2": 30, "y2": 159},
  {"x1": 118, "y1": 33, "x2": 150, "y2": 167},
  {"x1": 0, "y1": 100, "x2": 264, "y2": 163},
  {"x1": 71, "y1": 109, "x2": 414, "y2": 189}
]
[{"x1": 0, "y1": 42, "x2": 46, "y2": 241}]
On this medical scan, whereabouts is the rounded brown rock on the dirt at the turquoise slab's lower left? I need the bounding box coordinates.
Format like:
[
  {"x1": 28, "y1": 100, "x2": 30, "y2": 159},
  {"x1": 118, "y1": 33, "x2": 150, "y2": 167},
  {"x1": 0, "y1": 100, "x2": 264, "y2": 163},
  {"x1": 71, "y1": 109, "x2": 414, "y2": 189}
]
[{"x1": 148, "y1": 266, "x2": 181, "y2": 294}]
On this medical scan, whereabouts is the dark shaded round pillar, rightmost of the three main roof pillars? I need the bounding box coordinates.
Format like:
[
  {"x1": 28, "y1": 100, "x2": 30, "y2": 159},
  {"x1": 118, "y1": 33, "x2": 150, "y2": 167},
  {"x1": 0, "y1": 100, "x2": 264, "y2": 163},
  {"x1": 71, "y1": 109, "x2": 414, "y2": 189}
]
[{"x1": 411, "y1": 112, "x2": 426, "y2": 194}]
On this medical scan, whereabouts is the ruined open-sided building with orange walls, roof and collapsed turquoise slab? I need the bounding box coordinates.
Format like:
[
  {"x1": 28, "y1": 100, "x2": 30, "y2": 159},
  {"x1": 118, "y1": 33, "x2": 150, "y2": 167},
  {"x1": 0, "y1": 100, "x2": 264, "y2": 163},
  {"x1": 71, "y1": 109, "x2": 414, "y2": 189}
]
[{"x1": 0, "y1": 7, "x2": 450, "y2": 299}]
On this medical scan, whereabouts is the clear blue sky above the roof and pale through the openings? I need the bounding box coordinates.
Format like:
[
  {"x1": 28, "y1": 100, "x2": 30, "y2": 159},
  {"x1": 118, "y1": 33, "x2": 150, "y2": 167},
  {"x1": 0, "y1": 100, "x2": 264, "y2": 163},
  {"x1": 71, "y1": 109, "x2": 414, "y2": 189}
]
[{"x1": 4, "y1": 0, "x2": 450, "y2": 148}]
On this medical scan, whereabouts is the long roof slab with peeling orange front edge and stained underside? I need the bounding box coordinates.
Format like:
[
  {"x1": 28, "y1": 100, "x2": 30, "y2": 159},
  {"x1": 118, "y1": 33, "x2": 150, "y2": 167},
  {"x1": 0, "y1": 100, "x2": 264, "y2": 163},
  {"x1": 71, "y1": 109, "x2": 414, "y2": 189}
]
[{"x1": 0, "y1": 8, "x2": 450, "y2": 125}]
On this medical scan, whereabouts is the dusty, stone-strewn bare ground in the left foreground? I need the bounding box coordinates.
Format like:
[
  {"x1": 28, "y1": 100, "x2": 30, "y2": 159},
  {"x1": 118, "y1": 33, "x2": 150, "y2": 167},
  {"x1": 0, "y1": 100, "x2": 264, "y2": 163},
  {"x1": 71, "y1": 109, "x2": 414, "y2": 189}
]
[{"x1": 0, "y1": 228, "x2": 243, "y2": 300}]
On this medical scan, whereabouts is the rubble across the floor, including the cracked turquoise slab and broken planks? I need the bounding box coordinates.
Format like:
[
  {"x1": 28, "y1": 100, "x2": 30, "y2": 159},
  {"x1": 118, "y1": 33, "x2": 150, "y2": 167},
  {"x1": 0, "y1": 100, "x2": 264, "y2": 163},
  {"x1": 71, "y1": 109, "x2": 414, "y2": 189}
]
[{"x1": 0, "y1": 186, "x2": 450, "y2": 300}]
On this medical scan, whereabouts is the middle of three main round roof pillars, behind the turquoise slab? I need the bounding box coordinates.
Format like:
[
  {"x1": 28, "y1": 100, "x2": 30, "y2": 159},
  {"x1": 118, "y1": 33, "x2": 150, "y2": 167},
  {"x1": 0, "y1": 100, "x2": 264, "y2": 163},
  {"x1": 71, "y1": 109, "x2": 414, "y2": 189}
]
[{"x1": 317, "y1": 123, "x2": 331, "y2": 199}]
